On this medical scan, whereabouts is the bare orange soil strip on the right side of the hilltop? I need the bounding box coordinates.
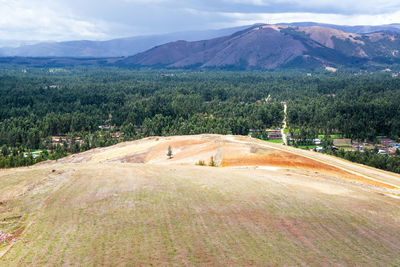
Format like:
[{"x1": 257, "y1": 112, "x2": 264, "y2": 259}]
[{"x1": 221, "y1": 144, "x2": 396, "y2": 189}]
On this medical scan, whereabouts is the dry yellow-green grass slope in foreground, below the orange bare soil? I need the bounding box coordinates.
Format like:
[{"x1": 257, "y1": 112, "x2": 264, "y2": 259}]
[{"x1": 0, "y1": 164, "x2": 400, "y2": 266}]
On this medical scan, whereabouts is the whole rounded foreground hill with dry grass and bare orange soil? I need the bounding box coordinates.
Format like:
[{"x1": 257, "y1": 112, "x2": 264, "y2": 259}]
[{"x1": 0, "y1": 135, "x2": 400, "y2": 266}]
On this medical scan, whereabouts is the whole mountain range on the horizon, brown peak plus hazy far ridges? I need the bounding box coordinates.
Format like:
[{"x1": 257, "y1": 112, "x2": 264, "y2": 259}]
[{"x1": 0, "y1": 22, "x2": 400, "y2": 69}]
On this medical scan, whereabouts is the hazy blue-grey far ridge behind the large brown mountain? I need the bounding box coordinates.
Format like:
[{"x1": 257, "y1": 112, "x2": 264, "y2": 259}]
[{"x1": 0, "y1": 22, "x2": 400, "y2": 58}]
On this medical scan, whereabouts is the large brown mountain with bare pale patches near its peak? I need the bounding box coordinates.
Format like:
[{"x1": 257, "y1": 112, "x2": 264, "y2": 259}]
[{"x1": 119, "y1": 25, "x2": 400, "y2": 69}]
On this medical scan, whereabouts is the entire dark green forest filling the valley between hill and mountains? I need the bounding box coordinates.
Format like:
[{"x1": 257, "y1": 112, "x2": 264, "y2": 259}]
[{"x1": 0, "y1": 67, "x2": 400, "y2": 172}]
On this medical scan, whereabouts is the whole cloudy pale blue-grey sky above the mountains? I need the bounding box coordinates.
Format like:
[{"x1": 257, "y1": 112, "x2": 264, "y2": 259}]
[{"x1": 0, "y1": 0, "x2": 400, "y2": 41}]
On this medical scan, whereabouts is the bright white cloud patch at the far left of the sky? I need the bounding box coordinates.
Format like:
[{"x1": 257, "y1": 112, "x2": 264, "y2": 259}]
[{"x1": 0, "y1": 0, "x2": 108, "y2": 41}]
